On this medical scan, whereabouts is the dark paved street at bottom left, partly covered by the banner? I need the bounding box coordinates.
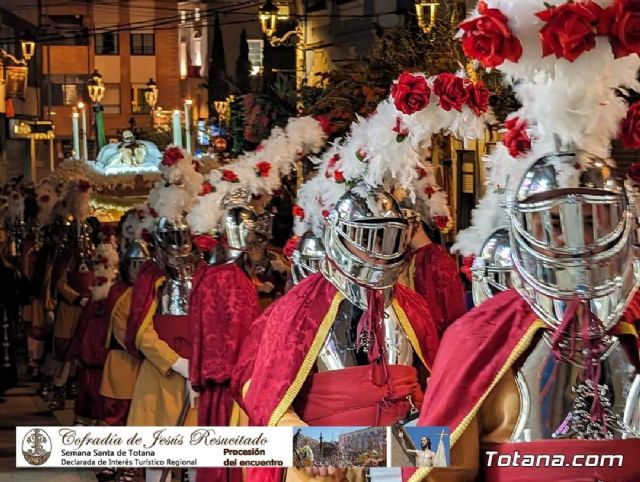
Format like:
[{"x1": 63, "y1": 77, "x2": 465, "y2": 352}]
[{"x1": 0, "y1": 367, "x2": 96, "y2": 482}]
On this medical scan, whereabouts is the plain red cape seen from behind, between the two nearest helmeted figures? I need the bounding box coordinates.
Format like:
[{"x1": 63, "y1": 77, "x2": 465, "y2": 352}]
[{"x1": 408, "y1": 243, "x2": 467, "y2": 334}]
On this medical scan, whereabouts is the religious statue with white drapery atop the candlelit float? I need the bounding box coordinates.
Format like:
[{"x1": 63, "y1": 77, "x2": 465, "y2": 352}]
[{"x1": 96, "y1": 130, "x2": 162, "y2": 174}]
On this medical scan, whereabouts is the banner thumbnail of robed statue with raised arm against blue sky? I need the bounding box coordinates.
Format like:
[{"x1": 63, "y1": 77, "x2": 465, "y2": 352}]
[{"x1": 390, "y1": 426, "x2": 450, "y2": 467}]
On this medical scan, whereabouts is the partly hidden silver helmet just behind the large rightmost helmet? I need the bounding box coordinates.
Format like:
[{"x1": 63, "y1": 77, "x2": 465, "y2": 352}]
[{"x1": 471, "y1": 228, "x2": 513, "y2": 306}]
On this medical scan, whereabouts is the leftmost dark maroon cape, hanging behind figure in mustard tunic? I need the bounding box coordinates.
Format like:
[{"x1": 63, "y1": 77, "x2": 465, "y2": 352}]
[{"x1": 67, "y1": 282, "x2": 127, "y2": 365}]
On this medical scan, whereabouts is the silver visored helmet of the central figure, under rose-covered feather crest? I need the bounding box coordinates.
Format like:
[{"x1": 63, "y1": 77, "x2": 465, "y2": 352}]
[{"x1": 321, "y1": 183, "x2": 408, "y2": 301}]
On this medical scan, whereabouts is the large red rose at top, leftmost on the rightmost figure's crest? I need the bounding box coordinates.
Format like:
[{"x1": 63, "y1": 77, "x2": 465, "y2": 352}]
[{"x1": 460, "y1": 2, "x2": 522, "y2": 68}]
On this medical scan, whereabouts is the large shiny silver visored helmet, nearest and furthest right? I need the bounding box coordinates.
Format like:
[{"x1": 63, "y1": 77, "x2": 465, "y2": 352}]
[{"x1": 509, "y1": 152, "x2": 636, "y2": 337}]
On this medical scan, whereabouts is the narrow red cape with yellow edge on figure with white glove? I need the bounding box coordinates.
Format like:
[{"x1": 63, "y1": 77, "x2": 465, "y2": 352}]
[{"x1": 125, "y1": 260, "x2": 164, "y2": 356}]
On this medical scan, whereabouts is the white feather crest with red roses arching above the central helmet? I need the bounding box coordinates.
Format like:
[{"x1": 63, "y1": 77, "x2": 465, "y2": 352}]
[{"x1": 294, "y1": 72, "x2": 489, "y2": 236}]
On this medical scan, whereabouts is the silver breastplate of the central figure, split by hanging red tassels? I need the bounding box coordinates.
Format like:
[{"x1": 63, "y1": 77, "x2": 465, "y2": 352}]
[{"x1": 316, "y1": 300, "x2": 414, "y2": 372}]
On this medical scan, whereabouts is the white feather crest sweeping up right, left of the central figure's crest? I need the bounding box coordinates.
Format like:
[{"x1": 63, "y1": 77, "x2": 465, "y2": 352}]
[{"x1": 187, "y1": 117, "x2": 326, "y2": 234}]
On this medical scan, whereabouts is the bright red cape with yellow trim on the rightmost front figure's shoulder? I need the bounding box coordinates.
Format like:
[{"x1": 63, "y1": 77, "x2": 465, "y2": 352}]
[{"x1": 403, "y1": 290, "x2": 545, "y2": 482}]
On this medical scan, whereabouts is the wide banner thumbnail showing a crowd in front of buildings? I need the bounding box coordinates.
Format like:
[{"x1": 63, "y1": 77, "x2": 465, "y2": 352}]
[{"x1": 293, "y1": 427, "x2": 387, "y2": 467}]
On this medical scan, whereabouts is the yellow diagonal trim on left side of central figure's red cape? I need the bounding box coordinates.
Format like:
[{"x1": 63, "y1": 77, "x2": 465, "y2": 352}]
[{"x1": 268, "y1": 291, "x2": 344, "y2": 427}]
